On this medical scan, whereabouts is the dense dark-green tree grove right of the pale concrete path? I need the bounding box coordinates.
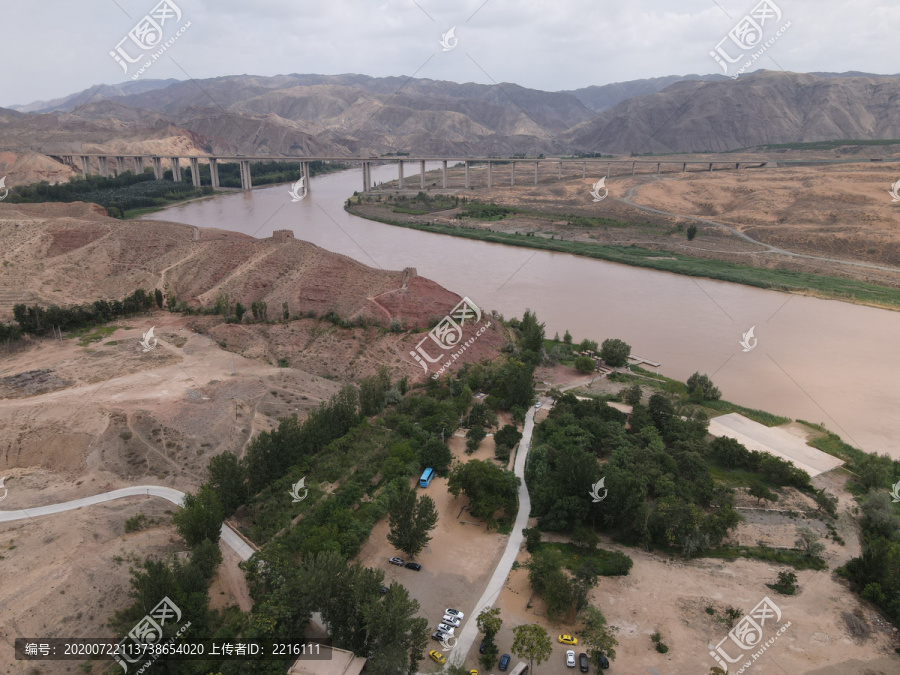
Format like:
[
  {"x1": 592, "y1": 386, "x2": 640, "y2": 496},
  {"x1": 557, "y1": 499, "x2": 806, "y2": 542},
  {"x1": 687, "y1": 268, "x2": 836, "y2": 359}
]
[{"x1": 526, "y1": 394, "x2": 740, "y2": 556}]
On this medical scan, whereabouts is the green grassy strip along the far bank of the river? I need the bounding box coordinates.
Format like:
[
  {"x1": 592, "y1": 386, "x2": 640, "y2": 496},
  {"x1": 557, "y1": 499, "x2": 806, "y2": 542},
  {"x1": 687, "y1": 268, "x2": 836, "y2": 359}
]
[{"x1": 344, "y1": 198, "x2": 900, "y2": 310}]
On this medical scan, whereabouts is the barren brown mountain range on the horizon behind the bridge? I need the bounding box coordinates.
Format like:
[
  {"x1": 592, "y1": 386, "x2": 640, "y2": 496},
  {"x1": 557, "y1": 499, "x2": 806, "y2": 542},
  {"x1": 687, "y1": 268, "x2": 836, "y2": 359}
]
[{"x1": 0, "y1": 71, "x2": 900, "y2": 156}]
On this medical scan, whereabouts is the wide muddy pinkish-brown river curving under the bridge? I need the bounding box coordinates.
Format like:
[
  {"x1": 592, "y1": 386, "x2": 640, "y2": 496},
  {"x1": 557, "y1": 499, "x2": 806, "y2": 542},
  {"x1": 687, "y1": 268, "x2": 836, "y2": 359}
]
[{"x1": 145, "y1": 165, "x2": 900, "y2": 458}]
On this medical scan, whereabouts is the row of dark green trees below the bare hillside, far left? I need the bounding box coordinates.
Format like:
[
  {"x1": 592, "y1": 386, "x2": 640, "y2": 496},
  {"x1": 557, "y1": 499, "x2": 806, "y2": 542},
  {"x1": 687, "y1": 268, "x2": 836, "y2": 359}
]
[{"x1": 13, "y1": 288, "x2": 156, "y2": 335}]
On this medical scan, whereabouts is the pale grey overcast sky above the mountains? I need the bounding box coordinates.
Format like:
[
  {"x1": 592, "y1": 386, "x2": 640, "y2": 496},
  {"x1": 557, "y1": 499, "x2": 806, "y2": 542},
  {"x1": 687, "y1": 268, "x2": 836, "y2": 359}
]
[{"x1": 0, "y1": 0, "x2": 900, "y2": 106}]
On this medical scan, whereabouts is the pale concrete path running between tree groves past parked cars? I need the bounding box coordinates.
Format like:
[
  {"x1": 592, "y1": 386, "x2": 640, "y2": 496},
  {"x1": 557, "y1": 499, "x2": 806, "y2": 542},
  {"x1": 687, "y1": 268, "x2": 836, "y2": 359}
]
[{"x1": 445, "y1": 398, "x2": 540, "y2": 668}]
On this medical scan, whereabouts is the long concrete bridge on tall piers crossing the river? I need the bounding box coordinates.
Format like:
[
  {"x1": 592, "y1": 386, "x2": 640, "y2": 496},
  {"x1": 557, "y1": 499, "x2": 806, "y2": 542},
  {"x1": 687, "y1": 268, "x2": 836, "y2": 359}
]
[{"x1": 51, "y1": 154, "x2": 777, "y2": 192}]
